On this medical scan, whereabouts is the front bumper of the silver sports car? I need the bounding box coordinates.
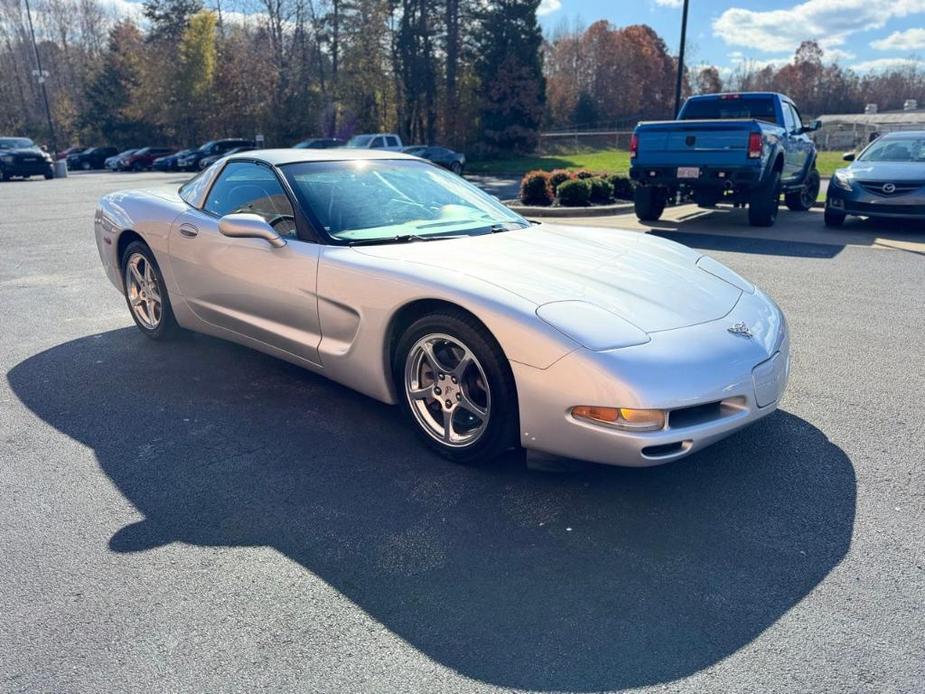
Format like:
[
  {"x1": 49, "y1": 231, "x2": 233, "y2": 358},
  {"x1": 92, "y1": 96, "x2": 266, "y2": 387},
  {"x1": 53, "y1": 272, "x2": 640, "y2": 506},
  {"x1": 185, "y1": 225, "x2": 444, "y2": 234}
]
[{"x1": 512, "y1": 292, "x2": 790, "y2": 467}]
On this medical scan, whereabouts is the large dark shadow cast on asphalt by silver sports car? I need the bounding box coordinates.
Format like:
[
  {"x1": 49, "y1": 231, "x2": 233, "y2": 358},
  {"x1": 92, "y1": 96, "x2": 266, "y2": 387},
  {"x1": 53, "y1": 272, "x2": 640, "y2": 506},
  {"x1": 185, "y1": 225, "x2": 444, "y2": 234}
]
[{"x1": 7, "y1": 328, "x2": 856, "y2": 691}]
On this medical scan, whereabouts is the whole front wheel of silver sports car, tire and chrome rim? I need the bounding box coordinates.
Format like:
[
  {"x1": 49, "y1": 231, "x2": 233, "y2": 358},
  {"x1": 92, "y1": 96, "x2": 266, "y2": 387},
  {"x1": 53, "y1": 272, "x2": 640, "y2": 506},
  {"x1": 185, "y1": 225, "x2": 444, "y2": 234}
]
[{"x1": 393, "y1": 311, "x2": 519, "y2": 464}]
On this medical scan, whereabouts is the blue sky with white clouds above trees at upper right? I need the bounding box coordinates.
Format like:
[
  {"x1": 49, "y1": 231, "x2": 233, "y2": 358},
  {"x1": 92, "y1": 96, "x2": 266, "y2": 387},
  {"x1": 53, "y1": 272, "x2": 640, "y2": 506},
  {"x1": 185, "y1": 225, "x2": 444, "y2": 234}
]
[{"x1": 539, "y1": 0, "x2": 925, "y2": 72}]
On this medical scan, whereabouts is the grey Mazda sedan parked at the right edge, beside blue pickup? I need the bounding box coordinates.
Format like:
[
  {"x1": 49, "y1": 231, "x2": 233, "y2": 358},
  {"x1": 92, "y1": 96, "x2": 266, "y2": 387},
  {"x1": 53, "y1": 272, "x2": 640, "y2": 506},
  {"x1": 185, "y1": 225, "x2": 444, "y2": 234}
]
[{"x1": 825, "y1": 131, "x2": 925, "y2": 227}]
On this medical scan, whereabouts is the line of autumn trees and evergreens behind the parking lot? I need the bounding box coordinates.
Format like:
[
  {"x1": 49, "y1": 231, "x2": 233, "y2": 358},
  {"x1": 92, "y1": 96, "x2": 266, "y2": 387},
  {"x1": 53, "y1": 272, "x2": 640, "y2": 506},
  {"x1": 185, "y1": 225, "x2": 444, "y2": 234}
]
[{"x1": 0, "y1": 0, "x2": 925, "y2": 154}]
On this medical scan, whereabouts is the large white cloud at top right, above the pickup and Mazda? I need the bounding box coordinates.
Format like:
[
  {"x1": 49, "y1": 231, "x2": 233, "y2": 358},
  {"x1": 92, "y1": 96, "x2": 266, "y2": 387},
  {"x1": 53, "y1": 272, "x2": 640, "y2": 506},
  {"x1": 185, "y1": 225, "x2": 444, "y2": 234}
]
[{"x1": 713, "y1": 0, "x2": 925, "y2": 53}]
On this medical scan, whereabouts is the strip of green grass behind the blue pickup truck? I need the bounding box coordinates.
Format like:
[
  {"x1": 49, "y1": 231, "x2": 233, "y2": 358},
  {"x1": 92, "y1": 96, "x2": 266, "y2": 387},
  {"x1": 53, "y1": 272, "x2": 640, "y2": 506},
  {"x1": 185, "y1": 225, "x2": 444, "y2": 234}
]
[{"x1": 466, "y1": 149, "x2": 845, "y2": 180}]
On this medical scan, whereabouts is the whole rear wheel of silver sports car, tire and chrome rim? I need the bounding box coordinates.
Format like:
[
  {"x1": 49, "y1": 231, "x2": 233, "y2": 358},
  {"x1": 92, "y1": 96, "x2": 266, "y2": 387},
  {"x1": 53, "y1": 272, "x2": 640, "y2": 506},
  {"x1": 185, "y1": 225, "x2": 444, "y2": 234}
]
[{"x1": 122, "y1": 241, "x2": 179, "y2": 340}]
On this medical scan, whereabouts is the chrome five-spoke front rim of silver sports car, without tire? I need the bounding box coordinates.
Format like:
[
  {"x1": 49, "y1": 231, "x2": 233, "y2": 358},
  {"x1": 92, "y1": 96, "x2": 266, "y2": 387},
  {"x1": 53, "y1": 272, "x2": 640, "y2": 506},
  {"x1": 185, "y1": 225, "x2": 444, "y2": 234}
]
[{"x1": 404, "y1": 333, "x2": 491, "y2": 448}]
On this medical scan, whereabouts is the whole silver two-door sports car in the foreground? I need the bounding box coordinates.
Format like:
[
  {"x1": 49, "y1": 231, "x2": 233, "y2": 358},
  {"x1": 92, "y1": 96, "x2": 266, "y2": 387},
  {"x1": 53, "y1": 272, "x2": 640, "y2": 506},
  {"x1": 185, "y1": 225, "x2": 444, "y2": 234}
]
[{"x1": 95, "y1": 149, "x2": 790, "y2": 466}]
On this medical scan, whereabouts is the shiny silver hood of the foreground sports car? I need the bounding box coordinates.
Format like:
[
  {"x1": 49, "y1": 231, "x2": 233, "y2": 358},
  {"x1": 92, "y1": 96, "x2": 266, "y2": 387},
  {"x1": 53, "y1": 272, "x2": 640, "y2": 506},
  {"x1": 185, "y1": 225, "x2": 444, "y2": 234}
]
[{"x1": 354, "y1": 224, "x2": 742, "y2": 333}]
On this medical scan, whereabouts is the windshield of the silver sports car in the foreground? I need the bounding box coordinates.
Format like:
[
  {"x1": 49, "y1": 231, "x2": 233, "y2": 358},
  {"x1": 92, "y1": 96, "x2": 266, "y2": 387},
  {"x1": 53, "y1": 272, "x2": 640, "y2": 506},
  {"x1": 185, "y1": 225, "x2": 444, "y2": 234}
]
[{"x1": 282, "y1": 159, "x2": 530, "y2": 242}]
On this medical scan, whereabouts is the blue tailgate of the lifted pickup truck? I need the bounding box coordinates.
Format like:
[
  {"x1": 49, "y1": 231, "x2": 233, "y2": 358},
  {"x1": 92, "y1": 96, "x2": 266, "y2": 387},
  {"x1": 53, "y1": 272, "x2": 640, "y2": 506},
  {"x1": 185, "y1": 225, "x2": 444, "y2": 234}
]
[{"x1": 637, "y1": 121, "x2": 757, "y2": 166}]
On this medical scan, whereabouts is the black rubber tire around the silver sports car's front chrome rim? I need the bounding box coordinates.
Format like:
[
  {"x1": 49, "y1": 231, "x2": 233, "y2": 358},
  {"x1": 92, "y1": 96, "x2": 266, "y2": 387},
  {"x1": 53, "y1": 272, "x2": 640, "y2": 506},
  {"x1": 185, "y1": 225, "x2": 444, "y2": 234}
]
[{"x1": 392, "y1": 309, "x2": 520, "y2": 465}]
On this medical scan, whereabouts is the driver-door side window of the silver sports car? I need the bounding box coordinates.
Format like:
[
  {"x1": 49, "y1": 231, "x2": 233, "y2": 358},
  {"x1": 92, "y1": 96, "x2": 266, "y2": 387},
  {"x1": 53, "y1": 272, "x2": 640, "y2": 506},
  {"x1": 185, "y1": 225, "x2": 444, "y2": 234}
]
[{"x1": 205, "y1": 161, "x2": 296, "y2": 237}]
